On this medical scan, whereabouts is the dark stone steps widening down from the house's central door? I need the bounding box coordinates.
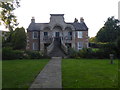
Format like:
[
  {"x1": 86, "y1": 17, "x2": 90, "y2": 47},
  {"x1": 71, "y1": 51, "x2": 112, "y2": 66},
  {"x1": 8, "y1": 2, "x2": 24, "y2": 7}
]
[{"x1": 48, "y1": 38, "x2": 66, "y2": 57}]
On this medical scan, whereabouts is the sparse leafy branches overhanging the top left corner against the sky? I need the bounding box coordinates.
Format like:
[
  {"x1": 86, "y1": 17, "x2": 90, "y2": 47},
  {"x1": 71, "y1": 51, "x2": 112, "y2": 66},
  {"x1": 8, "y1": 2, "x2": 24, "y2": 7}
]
[{"x1": 0, "y1": 0, "x2": 20, "y2": 32}]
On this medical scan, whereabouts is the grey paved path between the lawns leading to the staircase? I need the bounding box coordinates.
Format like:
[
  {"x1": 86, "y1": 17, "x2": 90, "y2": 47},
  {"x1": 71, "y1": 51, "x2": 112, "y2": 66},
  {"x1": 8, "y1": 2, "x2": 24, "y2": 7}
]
[{"x1": 30, "y1": 57, "x2": 62, "y2": 89}]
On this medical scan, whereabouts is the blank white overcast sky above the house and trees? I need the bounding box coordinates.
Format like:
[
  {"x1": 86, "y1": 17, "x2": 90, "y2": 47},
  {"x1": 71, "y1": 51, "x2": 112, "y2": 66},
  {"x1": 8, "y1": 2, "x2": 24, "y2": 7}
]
[{"x1": 1, "y1": 0, "x2": 120, "y2": 37}]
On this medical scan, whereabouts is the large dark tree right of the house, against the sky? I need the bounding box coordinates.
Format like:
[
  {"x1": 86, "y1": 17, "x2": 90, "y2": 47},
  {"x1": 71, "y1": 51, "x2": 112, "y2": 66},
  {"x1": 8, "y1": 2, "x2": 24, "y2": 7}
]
[{"x1": 96, "y1": 17, "x2": 120, "y2": 42}]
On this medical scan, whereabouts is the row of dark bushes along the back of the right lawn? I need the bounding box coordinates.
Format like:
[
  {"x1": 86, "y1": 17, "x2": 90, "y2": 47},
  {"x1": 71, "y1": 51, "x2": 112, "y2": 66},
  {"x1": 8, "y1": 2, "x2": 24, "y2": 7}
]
[{"x1": 69, "y1": 48, "x2": 115, "y2": 59}]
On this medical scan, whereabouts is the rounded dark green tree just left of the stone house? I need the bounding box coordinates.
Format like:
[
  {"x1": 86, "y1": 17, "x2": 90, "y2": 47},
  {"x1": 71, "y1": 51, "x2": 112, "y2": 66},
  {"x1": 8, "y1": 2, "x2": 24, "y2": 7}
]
[{"x1": 12, "y1": 27, "x2": 26, "y2": 49}]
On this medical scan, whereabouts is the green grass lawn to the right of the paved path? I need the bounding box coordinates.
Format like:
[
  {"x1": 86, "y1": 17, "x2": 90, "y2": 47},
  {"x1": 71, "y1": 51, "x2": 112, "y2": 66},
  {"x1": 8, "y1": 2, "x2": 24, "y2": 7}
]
[{"x1": 62, "y1": 59, "x2": 118, "y2": 88}]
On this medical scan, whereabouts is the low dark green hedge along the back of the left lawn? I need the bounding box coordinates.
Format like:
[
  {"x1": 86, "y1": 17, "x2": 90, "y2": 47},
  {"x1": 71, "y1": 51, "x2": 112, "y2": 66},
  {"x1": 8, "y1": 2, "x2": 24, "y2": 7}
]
[{"x1": 2, "y1": 47, "x2": 50, "y2": 60}]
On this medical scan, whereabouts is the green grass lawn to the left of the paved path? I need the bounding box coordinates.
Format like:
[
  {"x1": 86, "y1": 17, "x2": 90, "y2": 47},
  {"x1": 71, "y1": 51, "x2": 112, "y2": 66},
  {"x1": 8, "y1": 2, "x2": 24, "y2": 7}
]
[{"x1": 2, "y1": 60, "x2": 48, "y2": 88}]
